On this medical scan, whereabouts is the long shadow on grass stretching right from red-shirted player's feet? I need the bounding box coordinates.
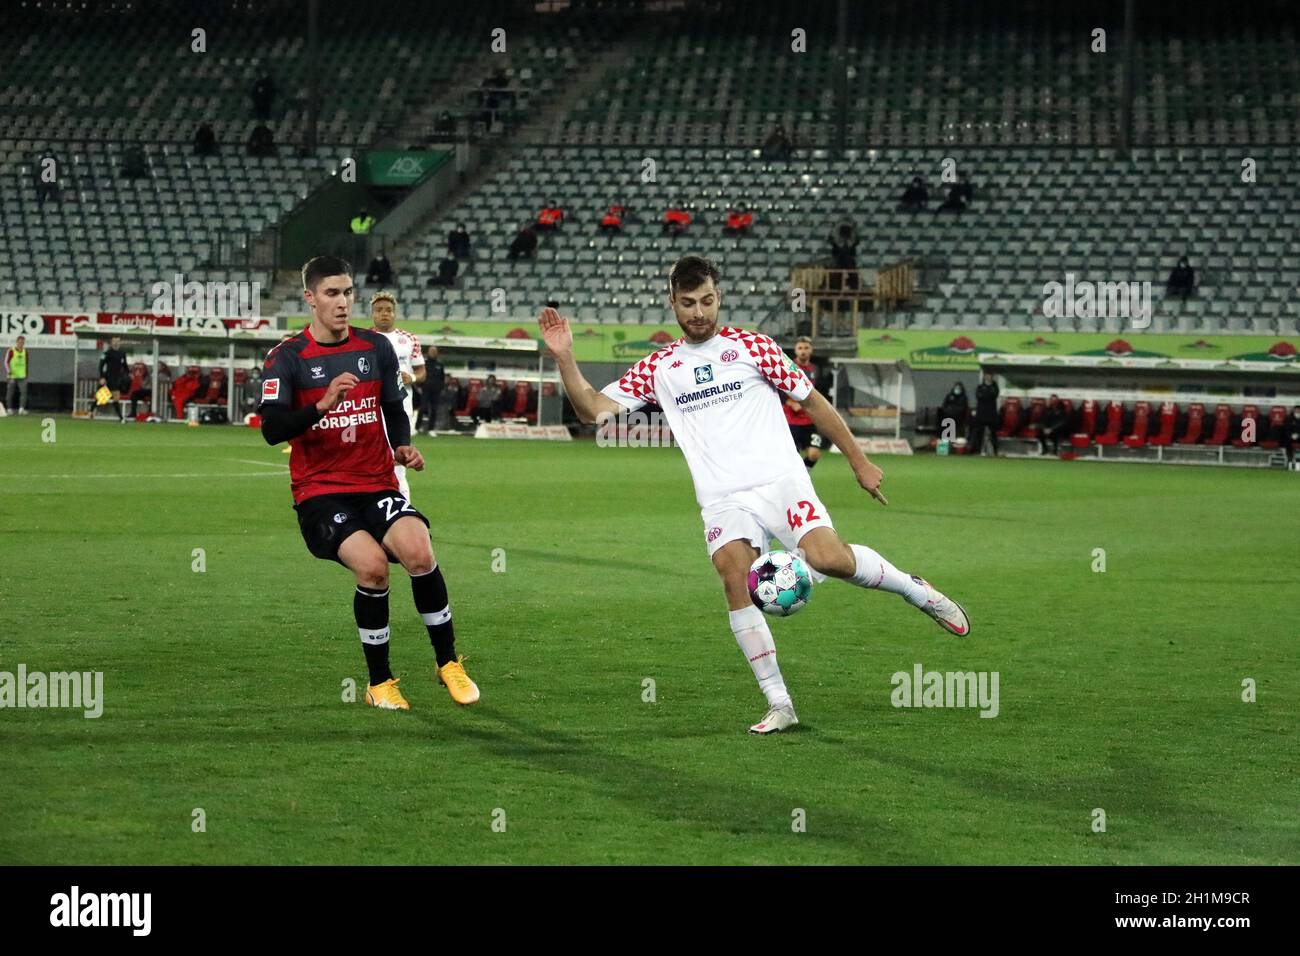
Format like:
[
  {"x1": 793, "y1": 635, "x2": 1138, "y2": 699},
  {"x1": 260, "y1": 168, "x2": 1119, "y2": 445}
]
[{"x1": 418, "y1": 711, "x2": 939, "y2": 864}]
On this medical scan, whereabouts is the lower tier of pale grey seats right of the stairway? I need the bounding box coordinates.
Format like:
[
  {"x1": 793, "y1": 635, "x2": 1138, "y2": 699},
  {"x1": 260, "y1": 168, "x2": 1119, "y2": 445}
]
[{"x1": 395, "y1": 146, "x2": 1300, "y2": 334}]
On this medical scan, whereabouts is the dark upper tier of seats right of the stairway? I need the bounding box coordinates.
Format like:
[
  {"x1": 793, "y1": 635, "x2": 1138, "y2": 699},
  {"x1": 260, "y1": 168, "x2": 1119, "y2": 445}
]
[{"x1": 560, "y1": 0, "x2": 1300, "y2": 147}]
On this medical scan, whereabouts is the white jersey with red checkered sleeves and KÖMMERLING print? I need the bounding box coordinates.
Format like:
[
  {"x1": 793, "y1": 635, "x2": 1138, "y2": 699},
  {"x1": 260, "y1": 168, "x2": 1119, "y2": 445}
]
[{"x1": 601, "y1": 328, "x2": 813, "y2": 507}]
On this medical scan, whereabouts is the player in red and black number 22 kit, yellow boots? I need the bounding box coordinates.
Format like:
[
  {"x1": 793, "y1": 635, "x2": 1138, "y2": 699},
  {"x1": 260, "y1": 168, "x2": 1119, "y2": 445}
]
[{"x1": 259, "y1": 256, "x2": 478, "y2": 710}]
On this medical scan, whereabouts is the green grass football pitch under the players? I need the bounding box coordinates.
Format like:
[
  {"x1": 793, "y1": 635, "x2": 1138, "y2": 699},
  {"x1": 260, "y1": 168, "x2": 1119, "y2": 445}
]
[{"x1": 0, "y1": 415, "x2": 1300, "y2": 864}]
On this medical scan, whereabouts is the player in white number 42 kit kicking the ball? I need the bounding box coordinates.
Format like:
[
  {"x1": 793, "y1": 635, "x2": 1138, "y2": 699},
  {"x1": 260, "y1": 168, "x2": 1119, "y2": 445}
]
[{"x1": 538, "y1": 256, "x2": 971, "y2": 734}]
